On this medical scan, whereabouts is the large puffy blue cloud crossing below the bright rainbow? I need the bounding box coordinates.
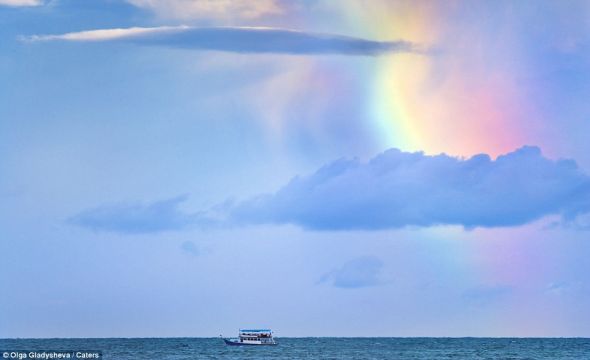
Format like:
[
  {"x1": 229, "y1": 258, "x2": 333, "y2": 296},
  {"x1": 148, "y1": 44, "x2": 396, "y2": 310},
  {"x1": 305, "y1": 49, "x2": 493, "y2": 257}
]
[{"x1": 226, "y1": 146, "x2": 590, "y2": 230}]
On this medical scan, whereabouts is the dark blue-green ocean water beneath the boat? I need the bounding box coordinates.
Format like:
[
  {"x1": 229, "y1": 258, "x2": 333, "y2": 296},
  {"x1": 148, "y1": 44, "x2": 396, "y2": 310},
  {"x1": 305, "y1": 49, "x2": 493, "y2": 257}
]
[{"x1": 0, "y1": 338, "x2": 590, "y2": 360}]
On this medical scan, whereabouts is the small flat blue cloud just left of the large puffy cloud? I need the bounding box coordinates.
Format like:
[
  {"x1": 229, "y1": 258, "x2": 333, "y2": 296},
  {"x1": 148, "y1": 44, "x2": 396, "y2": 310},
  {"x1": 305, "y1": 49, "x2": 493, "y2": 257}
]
[{"x1": 68, "y1": 195, "x2": 198, "y2": 234}]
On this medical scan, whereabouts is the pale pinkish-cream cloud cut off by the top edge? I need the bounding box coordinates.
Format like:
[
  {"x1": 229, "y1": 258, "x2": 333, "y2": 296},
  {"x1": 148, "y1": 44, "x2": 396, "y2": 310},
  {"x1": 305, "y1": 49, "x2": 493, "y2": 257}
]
[{"x1": 127, "y1": 0, "x2": 283, "y2": 20}]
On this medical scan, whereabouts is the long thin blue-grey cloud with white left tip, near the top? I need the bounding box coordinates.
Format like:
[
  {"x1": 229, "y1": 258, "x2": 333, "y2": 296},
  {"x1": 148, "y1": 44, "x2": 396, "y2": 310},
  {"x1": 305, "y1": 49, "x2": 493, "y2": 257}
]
[{"x1": 22, "y1": 26, "x2": 421, "y2": 55}]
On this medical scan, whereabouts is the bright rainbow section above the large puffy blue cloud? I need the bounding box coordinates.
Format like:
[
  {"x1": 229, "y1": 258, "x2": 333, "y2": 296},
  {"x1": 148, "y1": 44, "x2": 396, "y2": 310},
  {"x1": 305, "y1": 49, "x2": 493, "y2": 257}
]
[{"x1": 332, "y1": 1, "x2": 534, "y2": 156}]
